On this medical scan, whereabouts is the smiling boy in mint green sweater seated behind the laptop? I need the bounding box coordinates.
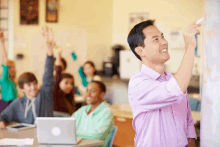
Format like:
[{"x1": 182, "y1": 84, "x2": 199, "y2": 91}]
[{"x1": 72, "y1": 81, "x2": 114, "y2": 146}]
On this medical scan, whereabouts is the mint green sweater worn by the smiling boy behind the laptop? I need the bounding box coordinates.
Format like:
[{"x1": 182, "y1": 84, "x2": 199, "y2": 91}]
[{"x1": 72, "y1": 101, "x2": 114, "y2": 147}]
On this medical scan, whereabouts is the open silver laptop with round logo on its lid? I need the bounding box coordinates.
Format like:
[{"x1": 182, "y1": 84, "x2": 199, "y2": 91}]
[{"x1": 36, "y1": 117, "x2": 82, "y2": 145}]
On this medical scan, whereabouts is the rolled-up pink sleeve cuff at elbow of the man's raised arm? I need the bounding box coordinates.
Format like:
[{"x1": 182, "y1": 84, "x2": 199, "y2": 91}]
[{"x1": 166, "y1": 77, "x2": 187, "y2": 103}]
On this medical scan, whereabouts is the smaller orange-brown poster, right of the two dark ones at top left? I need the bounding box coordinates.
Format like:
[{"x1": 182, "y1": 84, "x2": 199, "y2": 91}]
[{"x1": 46, "y1": 0, "x2": 59, "y2": 22}]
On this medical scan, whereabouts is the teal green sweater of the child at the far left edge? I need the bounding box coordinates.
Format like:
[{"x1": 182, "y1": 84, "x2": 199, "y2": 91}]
[{"x1": 0, "y1": 65, "x2": 17, "y2": 103}]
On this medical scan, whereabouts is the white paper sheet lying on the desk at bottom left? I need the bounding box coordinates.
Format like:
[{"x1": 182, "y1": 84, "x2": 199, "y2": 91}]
[{"x1": 0, "y1": 138, "x2": 34, "y2": 146}]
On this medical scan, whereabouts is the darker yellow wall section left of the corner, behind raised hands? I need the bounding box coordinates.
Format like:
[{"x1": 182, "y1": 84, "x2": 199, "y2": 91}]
[{"x1": 13, "y1": 0, "x2": 112, "y2": 83}]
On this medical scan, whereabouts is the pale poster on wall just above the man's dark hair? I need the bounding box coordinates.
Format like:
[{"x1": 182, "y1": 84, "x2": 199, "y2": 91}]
[{"x1": 129, "y1": 13, "x2": 149, "y2": 31}]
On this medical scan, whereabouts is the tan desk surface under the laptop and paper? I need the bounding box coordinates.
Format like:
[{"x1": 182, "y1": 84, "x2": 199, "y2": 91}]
[{"x1": 0, "y1": 128, "x2": 104, "y2": 147}]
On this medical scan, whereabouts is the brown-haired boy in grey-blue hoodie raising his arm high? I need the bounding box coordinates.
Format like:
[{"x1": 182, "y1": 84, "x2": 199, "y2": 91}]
[{"x1": 0, "y1": 27, "x2": 54, "y2": 128}]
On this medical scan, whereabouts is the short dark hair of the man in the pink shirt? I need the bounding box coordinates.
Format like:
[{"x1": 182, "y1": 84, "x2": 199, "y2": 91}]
[{"x1": 127, "y1": 20, "x2": 155, "y2": 60}]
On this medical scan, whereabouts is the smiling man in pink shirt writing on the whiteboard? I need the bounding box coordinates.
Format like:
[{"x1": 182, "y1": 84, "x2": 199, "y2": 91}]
[{"x1": 128, "y1": 20, "x2": 201, "y2": 147}]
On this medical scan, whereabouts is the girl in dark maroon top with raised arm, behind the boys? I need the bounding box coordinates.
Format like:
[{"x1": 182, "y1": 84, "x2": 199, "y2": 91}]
[{"x1": 53, "y1": 47, "x2": 76, "y2": 114}]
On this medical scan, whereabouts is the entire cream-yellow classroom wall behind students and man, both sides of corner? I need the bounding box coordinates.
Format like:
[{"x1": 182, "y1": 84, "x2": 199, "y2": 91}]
[{"x1": 8, "y1": 0, "x2": 203, "y2": 83}]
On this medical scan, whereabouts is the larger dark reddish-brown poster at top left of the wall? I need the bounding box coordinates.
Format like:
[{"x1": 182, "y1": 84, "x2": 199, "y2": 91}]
[{"x1": 20, "y1": 0, "x2": 39, "y2": 25}]
